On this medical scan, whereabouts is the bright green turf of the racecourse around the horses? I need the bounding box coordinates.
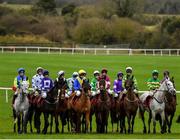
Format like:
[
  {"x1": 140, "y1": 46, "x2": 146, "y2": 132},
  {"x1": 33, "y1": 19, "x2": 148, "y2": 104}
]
[{"x1": 0, "y1": 53, "x2": 180, "y2": 138}]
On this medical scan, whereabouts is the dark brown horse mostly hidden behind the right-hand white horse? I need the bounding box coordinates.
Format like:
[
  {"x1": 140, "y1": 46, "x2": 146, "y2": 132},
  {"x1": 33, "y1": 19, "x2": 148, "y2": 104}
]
[{"x1": 165, "y1": 77, "x2": 176, "y2": 133}]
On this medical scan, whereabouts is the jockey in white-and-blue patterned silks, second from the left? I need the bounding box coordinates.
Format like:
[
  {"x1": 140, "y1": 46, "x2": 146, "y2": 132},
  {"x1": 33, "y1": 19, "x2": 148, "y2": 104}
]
[{"x1": 32, "y1": 67, "x2": 44, "y2": 95}]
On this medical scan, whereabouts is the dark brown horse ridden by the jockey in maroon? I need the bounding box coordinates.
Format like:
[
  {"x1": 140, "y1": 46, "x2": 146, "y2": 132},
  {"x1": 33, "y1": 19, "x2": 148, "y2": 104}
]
[{"x1": 95, "y1": 79, "x2": 111, "y2": 133}]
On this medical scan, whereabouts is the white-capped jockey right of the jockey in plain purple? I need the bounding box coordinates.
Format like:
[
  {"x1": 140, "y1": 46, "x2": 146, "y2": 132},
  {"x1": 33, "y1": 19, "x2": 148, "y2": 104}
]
[{"x1": 123, "y1": 67, "x2": 138, "y2": 96}]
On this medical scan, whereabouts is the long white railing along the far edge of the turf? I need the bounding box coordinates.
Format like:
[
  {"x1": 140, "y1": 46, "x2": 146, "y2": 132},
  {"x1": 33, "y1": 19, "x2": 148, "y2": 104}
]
[{"x1": 0, "y1": 46, "x2": 180, "y2": 56}]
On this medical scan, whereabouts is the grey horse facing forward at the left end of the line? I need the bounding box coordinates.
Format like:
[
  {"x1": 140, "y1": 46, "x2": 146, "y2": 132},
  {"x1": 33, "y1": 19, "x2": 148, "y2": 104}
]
[{"x1": 13, "y1": 81, "x2": 30, "y2": 134}]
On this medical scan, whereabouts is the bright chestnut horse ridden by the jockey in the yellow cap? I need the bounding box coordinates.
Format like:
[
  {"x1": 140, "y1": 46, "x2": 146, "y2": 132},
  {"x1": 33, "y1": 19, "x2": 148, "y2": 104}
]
[{"x1": 68, "y1": 80, "x2": 91, "y2": 133}]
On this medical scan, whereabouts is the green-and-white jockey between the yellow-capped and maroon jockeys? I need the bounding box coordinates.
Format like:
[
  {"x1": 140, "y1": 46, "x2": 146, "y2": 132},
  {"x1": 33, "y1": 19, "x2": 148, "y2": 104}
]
[{"x1": 91, "y1": 70, "x2": 100, "y2": 96}]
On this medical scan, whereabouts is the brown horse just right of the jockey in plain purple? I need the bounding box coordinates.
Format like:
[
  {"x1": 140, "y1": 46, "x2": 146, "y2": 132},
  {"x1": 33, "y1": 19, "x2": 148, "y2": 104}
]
[{"x1": 123, "y1": 76, "x2": 139, "y2": 133}]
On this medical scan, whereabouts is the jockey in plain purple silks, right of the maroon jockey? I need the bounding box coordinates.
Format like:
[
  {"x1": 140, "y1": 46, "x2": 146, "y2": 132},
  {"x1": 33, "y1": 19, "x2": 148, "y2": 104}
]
[{"x1": 113, "y1": 72, "x2": 124, "y2": 98}]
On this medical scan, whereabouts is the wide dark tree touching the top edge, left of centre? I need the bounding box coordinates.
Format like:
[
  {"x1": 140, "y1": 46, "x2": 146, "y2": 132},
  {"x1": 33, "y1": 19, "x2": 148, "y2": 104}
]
[{"x1": 33, "y1": 0, "x2": 57, "y2": 15}]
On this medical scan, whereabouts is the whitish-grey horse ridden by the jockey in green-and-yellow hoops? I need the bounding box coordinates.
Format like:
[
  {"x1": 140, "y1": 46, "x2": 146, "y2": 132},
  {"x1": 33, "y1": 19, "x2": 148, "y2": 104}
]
[{"x1": 139, "y1": 79, "x2": 176, "y2": 134}]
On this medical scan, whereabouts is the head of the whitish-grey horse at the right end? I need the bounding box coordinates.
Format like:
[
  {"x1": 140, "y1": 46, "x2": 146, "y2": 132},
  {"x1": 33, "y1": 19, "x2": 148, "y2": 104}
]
[{"x1": 160, "y1": 79, "x2": 176, "y2": 95}]
